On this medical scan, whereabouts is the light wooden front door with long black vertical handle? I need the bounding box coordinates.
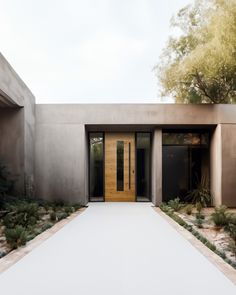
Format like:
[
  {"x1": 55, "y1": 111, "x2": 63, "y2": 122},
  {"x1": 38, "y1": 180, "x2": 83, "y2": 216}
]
[{"x1": 105, "y1": 133, "x2": 135, "y2": 202}]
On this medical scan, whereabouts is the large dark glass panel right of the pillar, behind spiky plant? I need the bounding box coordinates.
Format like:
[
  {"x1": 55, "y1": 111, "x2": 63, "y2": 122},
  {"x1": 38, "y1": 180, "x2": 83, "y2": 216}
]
[{"x1": 162, "y1": 132, "x2": 209, "y2": 202}]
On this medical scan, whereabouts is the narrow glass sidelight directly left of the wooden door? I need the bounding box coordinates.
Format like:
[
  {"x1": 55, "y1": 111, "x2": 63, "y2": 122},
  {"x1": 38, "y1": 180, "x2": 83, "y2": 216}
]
[{"x1": 89, "y1": 132, "x2": 104, "y2": 201}]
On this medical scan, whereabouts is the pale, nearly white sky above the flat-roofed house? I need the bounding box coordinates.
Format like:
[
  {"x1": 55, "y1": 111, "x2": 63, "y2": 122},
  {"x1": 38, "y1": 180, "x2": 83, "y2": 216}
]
[{"x1": 0, "y1": 0, "x2": 192, "y2": 103}]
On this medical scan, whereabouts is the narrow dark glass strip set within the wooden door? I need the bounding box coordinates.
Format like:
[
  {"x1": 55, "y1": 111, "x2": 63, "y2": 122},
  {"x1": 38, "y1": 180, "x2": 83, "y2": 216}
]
[{"x1": 116, "y1": 141, "x2": 124, "y2": 191}]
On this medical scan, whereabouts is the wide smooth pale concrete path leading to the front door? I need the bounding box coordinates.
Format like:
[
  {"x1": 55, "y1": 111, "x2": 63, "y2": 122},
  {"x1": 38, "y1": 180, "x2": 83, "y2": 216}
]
[{"x1": 0, "y1": 203, "x2": 236, "y2": 295}]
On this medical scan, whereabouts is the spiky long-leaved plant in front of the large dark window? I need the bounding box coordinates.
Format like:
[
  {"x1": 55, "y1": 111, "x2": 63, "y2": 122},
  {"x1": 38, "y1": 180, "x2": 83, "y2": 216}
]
[{"x1": 186, "y1": 176, "x2": 212, "y2": 207}]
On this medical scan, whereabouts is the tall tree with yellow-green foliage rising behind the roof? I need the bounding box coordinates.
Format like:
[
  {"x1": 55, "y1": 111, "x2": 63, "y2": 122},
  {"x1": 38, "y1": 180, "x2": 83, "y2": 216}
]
[{"x1": 155, "y1": 0, "x2": 236, "y2": 103}]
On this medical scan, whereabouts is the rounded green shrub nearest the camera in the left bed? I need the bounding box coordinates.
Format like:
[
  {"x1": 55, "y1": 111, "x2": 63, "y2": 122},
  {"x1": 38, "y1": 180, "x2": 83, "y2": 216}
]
[{"x1": 5, "y1": 225, "x2": 27, "y2": 249}]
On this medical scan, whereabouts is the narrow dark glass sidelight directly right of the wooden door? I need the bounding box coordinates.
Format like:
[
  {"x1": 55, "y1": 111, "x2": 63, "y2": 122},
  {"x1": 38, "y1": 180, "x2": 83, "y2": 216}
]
[{"x1": 136, "y1": 132, "x2": 151, "y2": 201}]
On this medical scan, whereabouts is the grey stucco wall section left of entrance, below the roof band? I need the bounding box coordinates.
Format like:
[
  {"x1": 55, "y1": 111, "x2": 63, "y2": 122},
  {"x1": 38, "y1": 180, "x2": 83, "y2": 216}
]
[{"x1": 35, "y1": 123, "x2": 88, "y2": 204}]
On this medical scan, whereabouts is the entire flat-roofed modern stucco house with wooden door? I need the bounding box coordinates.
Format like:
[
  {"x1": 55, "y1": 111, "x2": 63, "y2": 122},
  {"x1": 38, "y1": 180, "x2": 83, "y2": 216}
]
[{"x1": 0, "y1": 55, "x2": 236, "y2": 207}]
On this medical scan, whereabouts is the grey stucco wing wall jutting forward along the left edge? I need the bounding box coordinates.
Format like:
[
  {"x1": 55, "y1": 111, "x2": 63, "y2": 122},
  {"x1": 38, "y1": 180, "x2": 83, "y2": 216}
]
[{"x1": 0, "y1": 54, "x2": 35, "y2": 196}]
